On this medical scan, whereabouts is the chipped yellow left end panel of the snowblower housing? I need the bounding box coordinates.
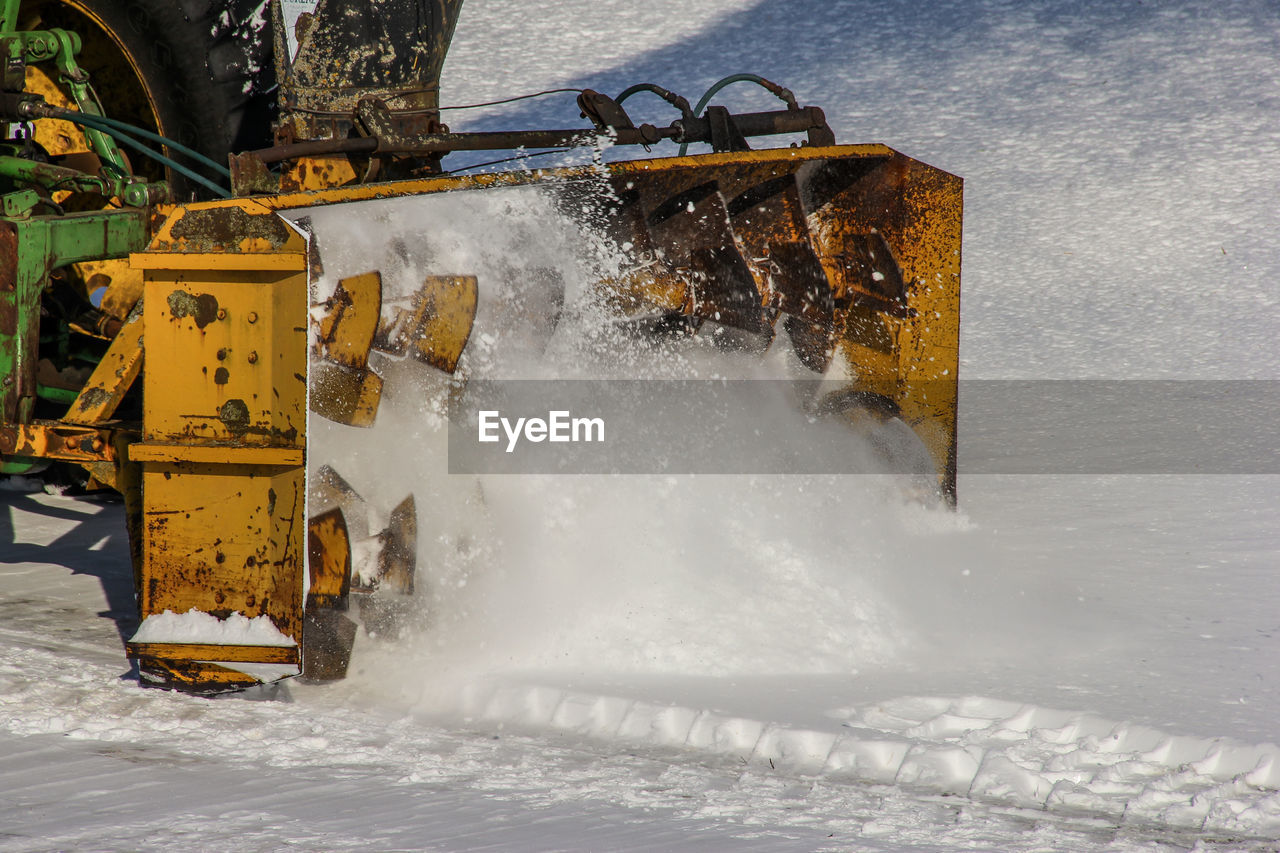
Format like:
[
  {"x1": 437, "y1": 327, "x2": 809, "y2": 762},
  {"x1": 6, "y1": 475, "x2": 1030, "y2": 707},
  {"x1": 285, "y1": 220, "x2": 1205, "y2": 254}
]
[{"x1": 129, "y1": 200, "x2": 307, "y2": 689}]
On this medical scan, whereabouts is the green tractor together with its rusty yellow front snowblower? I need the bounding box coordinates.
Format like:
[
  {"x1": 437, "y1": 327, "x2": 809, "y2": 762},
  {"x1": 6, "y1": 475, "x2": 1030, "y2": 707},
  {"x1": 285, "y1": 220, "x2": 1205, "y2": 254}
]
[{"x1": 0, "y1": 0, "x2": 961, "y2": 693}]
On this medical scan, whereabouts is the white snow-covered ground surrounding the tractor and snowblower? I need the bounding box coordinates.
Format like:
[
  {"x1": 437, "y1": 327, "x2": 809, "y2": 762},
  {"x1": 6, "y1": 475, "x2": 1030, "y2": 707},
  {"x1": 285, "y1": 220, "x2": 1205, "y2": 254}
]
[{"x1": 0, "y1": 0, "x2": 1280, "y2": 850}]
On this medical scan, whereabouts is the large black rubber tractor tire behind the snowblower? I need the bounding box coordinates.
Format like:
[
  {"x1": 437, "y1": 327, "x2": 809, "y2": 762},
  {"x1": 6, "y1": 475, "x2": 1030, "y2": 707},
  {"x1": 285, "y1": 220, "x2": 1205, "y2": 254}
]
[{"x1": 23, "y1": 0, "x2": 275, "y2": 200}]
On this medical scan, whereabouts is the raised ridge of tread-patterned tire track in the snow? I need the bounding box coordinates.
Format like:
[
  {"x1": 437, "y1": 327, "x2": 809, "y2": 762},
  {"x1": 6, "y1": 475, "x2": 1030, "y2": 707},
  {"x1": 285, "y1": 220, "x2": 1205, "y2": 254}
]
[{"x1": 462, "y1": 683, "x2": 1280, "y2": 839}]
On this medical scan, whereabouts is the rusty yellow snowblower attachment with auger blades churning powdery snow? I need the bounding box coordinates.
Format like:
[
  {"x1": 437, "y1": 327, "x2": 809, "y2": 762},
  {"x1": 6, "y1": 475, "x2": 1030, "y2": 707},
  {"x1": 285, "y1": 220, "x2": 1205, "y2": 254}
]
[{"x1": 117, "y1": 145, "x2": 961, "y2": 689}]
